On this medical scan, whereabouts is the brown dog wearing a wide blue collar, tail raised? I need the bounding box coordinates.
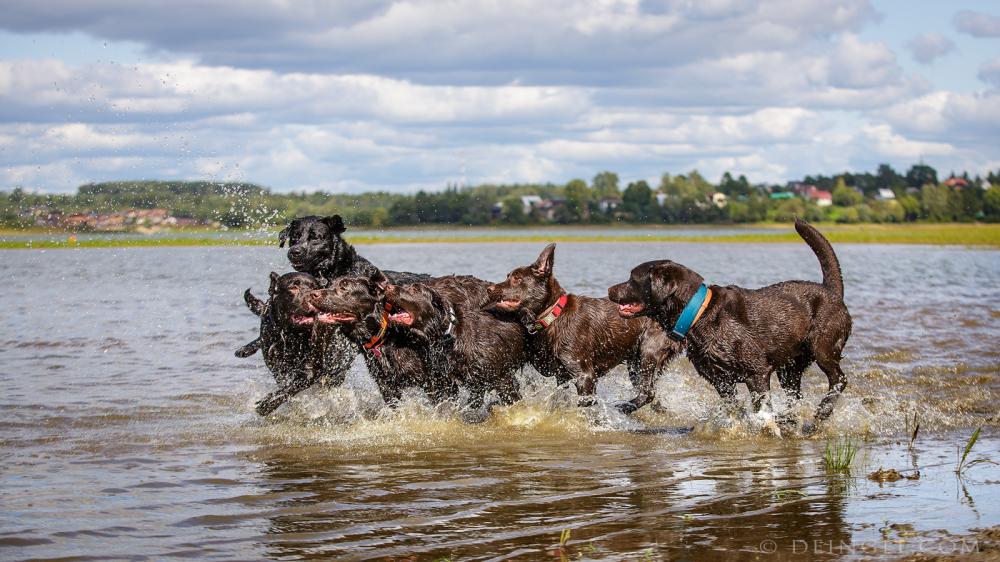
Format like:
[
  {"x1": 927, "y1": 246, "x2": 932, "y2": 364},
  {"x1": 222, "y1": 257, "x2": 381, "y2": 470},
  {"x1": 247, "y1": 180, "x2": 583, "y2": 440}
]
[{"x1": 608, "y1": 219, "x2": 851, "y2": 425}]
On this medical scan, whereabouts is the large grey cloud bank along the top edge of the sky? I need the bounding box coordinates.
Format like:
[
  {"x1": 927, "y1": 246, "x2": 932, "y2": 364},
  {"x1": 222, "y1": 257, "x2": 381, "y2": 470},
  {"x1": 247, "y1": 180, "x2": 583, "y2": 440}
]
[{"x1": 0, "y1": 0, "x2": 876, "y2": 84}]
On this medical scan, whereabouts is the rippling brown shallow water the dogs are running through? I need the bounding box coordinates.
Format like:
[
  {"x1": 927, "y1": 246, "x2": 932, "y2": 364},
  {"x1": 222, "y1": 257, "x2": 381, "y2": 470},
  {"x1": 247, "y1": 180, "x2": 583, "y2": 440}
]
[{"x1": 0, "y1": 243, "x2": 1000, "y2": 560}]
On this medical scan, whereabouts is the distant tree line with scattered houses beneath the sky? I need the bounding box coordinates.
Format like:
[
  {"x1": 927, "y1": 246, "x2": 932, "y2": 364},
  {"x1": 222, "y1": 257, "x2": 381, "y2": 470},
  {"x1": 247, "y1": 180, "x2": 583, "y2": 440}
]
[{"x1": 0, "y1": 164, "x2": 1000, "y2": 228}]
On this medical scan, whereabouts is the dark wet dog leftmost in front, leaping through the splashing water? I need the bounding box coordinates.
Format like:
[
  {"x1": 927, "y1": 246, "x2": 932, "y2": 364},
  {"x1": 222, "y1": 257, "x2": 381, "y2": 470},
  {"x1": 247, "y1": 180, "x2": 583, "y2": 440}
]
[{"x1": 236, "y1": 272, "x2": 354, "y2": 415}]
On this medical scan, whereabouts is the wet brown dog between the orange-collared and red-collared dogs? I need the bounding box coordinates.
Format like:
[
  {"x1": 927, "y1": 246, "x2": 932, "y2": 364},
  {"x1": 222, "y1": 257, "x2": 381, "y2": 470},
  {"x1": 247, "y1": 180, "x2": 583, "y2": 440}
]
[{"x1": 385, "y1": 275, "x2": 527, "y2": 421}]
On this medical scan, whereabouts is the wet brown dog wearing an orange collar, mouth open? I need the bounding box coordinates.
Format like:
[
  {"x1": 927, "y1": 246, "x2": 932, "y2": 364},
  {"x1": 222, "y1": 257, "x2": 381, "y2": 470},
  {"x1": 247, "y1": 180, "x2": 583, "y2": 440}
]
[{"x1": 309, "y1": 269, "x2": 458, "y2": 406}]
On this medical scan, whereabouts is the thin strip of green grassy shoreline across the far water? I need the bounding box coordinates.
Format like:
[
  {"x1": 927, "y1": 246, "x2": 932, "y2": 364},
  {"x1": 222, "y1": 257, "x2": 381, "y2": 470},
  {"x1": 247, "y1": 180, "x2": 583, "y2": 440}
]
[{"x1": 0, "y1": 224, "x2": 1000, "y2": 249}]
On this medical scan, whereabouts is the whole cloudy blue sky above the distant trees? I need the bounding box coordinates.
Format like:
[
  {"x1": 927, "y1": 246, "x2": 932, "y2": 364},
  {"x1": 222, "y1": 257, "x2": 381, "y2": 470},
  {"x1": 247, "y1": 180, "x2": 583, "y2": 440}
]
[{"x1": 0, "y1": 0, "x2": 1000, "y2": 192}]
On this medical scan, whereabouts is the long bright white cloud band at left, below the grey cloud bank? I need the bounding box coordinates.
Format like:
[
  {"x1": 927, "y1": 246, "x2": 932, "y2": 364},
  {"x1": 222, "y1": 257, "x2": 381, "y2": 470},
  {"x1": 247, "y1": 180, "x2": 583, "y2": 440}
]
[{"x1": 0, "y1": 61, "x2": 588, "y2": 123}]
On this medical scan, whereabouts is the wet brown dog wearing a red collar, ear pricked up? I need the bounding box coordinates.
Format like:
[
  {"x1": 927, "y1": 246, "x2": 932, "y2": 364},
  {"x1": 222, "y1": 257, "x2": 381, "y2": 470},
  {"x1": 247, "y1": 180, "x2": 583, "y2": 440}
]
[{"x1": 488, "y1": 244, "x2": 680, "y2": 413}]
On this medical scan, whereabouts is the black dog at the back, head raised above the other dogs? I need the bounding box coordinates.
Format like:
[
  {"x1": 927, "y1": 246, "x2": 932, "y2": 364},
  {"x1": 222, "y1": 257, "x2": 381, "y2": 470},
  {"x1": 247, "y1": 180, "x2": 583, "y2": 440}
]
[{"x1": 278, "y1": 215, "x2": 430, "y2": 285}]
